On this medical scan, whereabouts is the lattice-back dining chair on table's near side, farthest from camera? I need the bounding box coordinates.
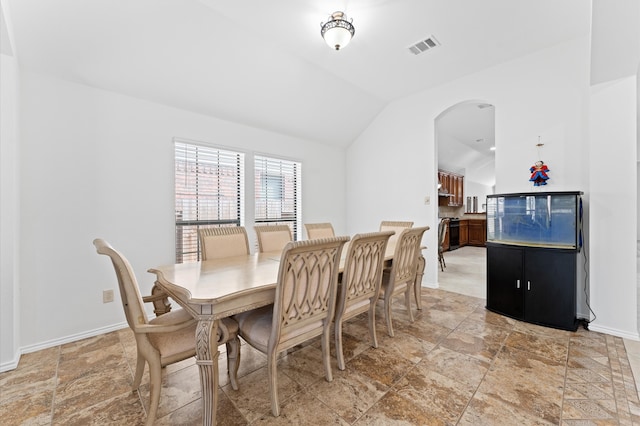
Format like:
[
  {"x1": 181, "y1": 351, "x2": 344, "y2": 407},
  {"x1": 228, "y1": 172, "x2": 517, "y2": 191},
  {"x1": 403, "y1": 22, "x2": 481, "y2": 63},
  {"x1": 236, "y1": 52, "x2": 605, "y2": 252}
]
[{"x1": 380, "y1": 226, "x2": 429, "y2": 337}]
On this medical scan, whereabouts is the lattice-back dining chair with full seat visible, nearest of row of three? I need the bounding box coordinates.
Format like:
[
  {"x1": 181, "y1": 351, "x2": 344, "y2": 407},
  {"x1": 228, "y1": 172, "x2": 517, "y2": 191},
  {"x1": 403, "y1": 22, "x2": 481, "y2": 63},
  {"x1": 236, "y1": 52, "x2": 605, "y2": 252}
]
[{"x1": 235, "y1": 236, "x2": 349, "y2": 417}]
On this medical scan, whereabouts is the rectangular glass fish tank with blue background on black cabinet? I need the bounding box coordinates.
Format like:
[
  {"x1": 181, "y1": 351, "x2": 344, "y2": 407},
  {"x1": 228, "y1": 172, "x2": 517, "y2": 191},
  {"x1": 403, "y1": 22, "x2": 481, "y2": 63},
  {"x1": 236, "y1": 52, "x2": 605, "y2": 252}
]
[{"x1": 487, "y1": 192, "x2": 582, "y2": 250}]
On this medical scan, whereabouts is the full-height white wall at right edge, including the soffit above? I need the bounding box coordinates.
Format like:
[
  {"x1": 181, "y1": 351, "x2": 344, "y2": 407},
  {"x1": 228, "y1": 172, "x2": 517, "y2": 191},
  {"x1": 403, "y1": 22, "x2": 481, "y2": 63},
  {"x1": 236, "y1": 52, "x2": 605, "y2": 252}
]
[{"x1": 587, "y1": 0, "x2": 640, "y2": 339}]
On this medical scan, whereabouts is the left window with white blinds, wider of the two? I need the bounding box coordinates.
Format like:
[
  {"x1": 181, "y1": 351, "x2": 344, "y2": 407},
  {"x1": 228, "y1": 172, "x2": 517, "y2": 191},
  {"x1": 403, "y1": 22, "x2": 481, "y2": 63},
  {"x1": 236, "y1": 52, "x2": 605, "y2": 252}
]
[{"x1": 175, "y1": 141, "x2": 244, "y2": 263}]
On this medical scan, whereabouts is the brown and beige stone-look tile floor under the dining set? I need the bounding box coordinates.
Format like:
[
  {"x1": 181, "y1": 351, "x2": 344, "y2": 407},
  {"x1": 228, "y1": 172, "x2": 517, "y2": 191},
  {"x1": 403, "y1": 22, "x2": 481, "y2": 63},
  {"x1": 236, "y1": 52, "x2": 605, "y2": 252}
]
[{"x1": 0, "y1": 248, "x2": 640, "y2": 425}]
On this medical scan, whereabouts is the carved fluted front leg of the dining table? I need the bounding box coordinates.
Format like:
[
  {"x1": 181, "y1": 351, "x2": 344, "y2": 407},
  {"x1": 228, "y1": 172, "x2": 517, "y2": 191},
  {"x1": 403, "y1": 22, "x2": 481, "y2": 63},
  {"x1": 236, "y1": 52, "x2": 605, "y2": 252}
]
[{"x1": 196, "y1": 319, "x2": 220, "y2": 426}]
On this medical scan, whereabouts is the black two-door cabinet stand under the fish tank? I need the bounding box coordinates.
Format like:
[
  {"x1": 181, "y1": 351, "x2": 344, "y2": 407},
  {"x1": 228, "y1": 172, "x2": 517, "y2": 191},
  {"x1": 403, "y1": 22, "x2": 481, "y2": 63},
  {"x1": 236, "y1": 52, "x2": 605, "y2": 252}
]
[{"x1": 487, "y1": 243, "x2": 578, "y2": 331}]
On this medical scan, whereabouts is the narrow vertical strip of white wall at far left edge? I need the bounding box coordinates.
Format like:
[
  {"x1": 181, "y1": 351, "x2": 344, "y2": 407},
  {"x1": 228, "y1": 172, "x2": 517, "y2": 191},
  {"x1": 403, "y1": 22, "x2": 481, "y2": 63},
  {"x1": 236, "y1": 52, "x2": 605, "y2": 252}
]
[{"x1": 0, "y1": 54, "x2": 20, "y2": 371}]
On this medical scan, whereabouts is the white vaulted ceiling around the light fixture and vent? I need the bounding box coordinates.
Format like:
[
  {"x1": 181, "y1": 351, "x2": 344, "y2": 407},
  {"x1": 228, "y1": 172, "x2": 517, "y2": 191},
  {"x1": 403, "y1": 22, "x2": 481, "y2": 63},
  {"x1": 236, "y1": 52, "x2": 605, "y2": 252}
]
[{"x1": 0, "y1": 0, "x2": 590, "y2": 147}]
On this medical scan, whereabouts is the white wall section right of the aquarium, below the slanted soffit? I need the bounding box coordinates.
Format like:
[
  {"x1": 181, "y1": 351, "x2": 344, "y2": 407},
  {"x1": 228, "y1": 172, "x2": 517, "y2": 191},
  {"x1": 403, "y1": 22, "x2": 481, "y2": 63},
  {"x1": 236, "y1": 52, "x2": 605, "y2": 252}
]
[{"x1": 588, "y1": 76, "x2": 638, "y2": 339}]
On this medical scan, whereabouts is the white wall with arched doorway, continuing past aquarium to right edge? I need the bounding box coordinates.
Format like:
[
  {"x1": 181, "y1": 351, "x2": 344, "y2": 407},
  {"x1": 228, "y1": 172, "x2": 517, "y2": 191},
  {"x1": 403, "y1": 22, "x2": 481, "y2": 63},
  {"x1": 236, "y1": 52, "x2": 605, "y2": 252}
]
[{"x1": 347, "y1": 30, "x2": 638, "y2": 339}]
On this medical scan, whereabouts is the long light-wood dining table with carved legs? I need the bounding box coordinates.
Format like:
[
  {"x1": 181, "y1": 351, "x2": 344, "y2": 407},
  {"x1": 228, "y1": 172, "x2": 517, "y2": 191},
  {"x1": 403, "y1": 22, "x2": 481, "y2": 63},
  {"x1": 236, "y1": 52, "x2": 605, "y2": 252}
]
[{"x1": 148, "y1": 243, "x2": 425, "y2": 426}]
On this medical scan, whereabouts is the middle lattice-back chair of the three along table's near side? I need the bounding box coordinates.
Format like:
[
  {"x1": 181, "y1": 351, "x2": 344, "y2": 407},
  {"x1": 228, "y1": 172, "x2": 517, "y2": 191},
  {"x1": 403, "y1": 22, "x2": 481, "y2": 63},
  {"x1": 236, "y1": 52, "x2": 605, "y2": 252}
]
[{"x1": 334, "y1": 231, "x2": 393, "y2": 370}]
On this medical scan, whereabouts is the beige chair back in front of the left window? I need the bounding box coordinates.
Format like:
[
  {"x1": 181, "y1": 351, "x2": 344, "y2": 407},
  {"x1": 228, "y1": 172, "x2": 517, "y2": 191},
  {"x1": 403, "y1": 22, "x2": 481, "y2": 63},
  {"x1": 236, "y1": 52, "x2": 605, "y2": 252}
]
[{"x1": 198, "y1": 226, "x2": 251, "y2": 260}]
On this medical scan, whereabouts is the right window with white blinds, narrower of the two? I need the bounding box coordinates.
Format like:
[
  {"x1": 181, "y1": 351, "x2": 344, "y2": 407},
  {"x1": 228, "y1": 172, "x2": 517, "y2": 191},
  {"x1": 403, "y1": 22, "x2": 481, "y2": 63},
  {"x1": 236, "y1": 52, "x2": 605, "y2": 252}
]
[{"x1": 255, "y1": 156, "x2": 301, "y2": 241}]
